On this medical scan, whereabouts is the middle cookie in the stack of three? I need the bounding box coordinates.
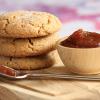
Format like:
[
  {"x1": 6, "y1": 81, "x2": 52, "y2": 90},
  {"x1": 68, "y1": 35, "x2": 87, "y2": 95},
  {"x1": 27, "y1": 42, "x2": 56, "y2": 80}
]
[{"x1": 0, "y1": 33, "x2": 58, "y2": 57}]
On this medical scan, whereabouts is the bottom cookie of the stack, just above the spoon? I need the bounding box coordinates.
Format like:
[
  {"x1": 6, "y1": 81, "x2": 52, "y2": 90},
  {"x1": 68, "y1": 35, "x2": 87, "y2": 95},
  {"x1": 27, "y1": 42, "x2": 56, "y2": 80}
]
[{"x1": 0, "y1": 52, "x2": 55, "y2": 69}]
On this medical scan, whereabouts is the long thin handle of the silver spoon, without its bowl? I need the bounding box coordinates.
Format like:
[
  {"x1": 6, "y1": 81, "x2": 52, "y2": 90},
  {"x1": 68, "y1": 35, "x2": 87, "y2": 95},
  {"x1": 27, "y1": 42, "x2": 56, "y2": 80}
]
[{"x1": 26, "y1": 73, "x2": 100, "y2": 81}]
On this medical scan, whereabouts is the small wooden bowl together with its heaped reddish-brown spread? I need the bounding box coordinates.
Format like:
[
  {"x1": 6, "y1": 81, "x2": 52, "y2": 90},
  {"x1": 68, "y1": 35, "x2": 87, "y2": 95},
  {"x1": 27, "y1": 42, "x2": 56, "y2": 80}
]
[{"x1": 57, "y1": 29, "x2": 100, "y2": 75}]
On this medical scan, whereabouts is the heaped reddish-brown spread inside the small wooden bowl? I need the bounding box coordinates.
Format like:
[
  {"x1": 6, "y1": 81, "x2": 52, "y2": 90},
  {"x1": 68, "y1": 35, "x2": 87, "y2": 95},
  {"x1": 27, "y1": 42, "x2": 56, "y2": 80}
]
[{"x1": 61, "y1": 29, "x2": 100, "y2": 48}]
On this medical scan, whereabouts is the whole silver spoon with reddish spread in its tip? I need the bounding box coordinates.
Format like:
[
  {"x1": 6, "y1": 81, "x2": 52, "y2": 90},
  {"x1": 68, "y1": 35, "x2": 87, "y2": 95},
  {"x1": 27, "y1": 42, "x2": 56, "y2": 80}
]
[{"x1": 0, "y1": 65, "x2": 100, "y2": 81}]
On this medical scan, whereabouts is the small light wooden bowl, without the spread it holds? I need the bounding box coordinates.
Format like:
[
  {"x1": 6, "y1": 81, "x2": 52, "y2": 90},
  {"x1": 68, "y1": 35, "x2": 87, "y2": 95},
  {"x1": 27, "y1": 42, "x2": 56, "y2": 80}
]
[{"x1": 57, "y1": 37, "x2": 100, "y2": 74}]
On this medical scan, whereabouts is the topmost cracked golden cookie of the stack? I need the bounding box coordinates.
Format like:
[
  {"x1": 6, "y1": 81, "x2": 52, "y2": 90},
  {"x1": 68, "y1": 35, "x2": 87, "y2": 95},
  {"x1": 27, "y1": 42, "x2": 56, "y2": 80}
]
[{"x1": 0, "y1": 11, "x2": 61, "y2": 38}]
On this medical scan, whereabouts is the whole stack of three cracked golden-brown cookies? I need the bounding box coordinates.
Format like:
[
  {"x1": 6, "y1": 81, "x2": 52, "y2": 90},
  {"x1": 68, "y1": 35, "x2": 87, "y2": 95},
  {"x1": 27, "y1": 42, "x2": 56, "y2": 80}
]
[{"x1": 0, "y1": 11, "x2": 61, "y2": 69}]
